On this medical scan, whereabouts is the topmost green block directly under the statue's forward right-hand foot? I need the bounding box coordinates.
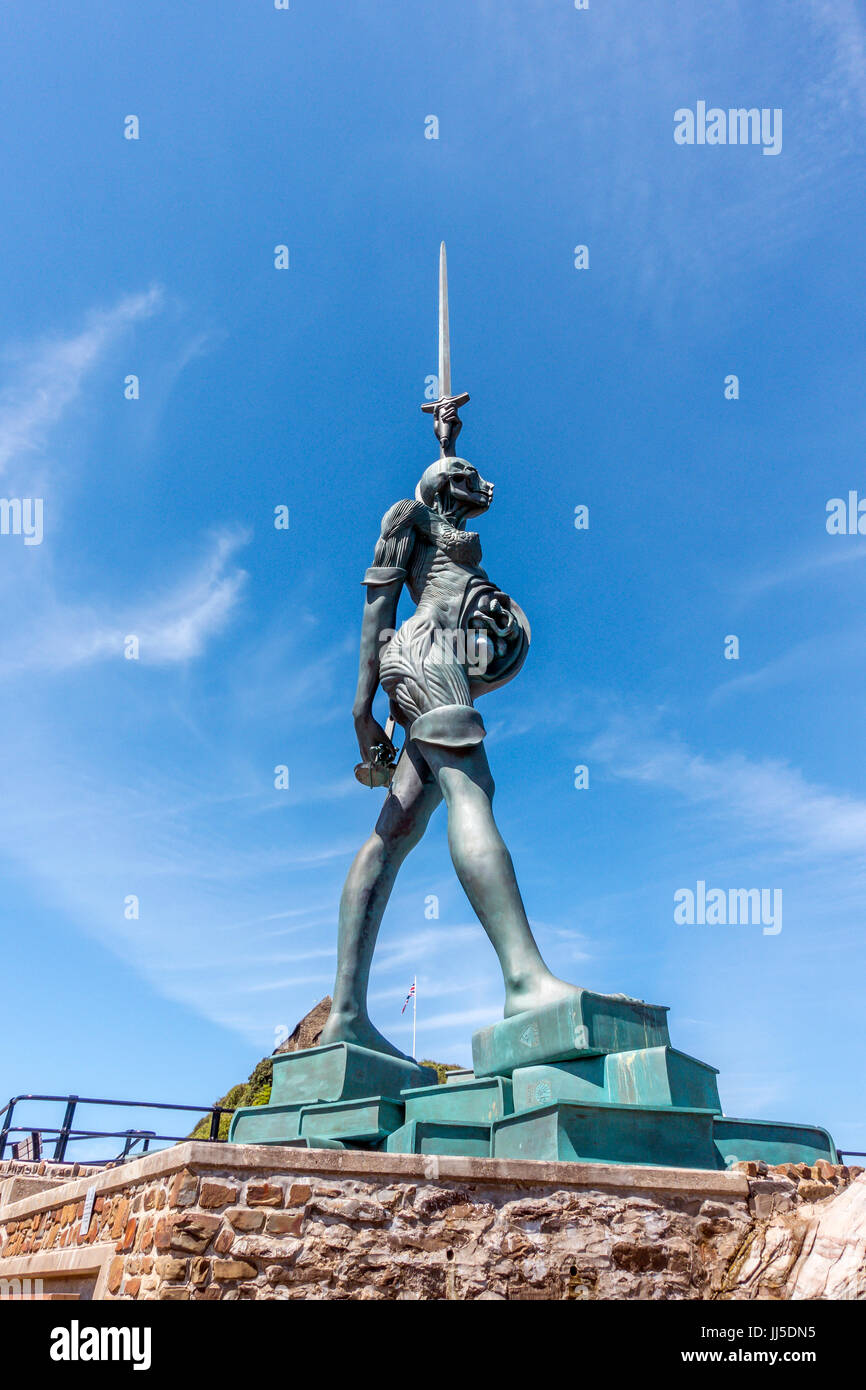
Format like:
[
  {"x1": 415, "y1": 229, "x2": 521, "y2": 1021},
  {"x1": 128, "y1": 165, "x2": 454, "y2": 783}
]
[{"x1": 473, "y1": 990, "x2": 670, "y2": 1077}]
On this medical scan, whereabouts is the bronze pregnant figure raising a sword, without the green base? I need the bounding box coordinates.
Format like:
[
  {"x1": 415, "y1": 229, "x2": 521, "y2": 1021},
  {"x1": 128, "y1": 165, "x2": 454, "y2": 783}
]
[{"x1": 321, "y1": 243, "x2": 577, "y2": 1055}]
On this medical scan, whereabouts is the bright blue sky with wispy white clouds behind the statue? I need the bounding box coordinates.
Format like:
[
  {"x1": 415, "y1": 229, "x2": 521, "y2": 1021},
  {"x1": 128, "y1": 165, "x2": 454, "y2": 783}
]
[{"x1": 0, "y1": 0, "x2": 866, "y2": 1150}]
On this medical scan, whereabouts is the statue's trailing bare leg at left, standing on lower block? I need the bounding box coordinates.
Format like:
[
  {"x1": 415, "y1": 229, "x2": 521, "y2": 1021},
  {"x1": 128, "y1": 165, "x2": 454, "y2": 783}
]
[{"x1": 321, "y1": 739, "x2": 442, "y2": 1056}]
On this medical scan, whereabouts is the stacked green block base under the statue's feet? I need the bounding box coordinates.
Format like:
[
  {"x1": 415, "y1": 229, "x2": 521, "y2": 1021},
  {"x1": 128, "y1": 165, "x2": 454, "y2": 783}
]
[{"x1": 228, "y1": 1006, "x2": 838, "y2": 1169}]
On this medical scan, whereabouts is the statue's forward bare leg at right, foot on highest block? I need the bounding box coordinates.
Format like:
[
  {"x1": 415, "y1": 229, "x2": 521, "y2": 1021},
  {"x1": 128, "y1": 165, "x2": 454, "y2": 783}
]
[{"x1": 421, "y1": 742, "x2": 577, "y2": 1019}]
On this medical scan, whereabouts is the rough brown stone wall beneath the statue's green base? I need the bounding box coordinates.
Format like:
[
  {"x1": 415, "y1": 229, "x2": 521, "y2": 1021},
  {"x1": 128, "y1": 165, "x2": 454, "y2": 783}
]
[{"x1": 0, "y1": 1143, "x2": 866, "y2": 1301}]
